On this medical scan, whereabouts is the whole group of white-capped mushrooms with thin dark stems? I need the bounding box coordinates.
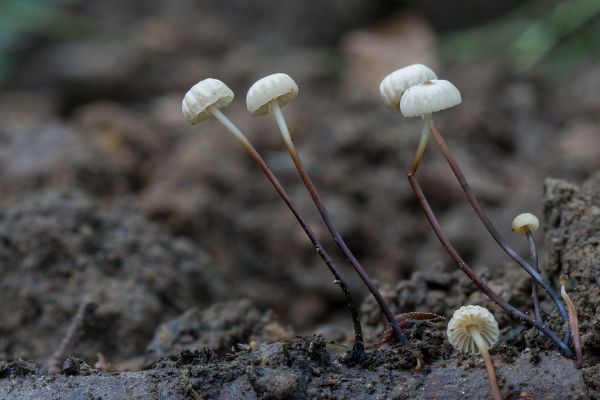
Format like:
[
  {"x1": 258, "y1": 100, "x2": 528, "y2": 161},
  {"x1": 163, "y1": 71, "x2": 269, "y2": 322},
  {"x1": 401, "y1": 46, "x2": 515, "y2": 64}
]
[{"x1": 182, "y1": 64, "x2": 581, "y2": 399}]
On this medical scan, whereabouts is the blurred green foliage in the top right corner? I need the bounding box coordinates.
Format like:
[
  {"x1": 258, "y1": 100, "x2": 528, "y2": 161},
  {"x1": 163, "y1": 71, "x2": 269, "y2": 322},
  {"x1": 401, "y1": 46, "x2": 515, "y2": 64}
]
[{"x1": 442, "y1": 0, "x2": 600, "y2": 76}]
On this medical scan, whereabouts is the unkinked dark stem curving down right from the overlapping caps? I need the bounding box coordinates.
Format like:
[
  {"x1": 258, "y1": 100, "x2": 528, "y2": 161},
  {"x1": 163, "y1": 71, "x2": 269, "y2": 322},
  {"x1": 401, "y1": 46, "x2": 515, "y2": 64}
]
[{"x1": 430, "y1": 121, "x2": 571, "y2": 343}]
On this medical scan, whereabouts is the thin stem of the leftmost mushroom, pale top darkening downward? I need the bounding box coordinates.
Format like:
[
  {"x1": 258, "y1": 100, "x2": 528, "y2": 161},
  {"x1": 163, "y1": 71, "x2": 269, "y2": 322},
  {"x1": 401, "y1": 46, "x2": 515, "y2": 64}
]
[{"x1": 208, "y1": 106, "x2": 365, "y2": 362}]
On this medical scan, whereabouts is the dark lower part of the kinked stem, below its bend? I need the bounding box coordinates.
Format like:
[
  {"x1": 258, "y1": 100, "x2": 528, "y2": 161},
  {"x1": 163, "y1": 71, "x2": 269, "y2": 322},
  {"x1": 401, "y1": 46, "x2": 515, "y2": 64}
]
[{"x1": 408, "y1": 171, "x2": 573, "y2": 357}]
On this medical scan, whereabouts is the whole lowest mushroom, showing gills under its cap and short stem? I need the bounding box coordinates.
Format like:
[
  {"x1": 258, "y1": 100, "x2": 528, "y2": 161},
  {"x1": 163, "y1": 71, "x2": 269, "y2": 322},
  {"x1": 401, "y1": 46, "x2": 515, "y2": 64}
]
[{"x1": 448, "y1": 306, "x2": 502, "y2": 400}]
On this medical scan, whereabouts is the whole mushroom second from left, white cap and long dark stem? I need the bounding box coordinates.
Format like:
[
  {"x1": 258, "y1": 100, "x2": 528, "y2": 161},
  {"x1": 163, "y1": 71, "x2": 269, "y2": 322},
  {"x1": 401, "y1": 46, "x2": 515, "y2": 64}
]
[{"x1": 246, "y1": 73, "x2": 407, "y2": 343}]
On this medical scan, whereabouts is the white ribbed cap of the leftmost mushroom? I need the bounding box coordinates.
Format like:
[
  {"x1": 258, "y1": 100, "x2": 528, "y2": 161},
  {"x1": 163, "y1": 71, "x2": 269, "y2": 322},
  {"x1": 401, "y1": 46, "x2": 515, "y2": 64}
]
[{"x1": 181, "y1": 78, "x2": 233, "y2": 124}]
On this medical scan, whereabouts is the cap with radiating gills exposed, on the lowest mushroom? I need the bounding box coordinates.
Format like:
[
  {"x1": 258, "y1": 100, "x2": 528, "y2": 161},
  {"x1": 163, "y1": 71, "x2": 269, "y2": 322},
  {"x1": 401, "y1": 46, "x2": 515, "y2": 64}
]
[{"x1": 448, "y1": 306, "x2": 500, "y2": 354}]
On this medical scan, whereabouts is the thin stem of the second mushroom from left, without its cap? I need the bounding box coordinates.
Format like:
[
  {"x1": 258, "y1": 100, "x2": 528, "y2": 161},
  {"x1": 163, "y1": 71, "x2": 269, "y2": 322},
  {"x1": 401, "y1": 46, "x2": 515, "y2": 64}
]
[{"x1": 269, "y1": 101, "x2": 408, "y2": 343}]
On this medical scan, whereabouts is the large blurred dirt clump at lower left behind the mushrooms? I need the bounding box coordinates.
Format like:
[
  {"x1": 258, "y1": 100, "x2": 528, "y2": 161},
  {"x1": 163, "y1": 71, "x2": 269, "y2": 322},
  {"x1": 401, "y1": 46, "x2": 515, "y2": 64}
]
[{"x1": 0, "y1": 192, "x2": 221, "y2": 360}]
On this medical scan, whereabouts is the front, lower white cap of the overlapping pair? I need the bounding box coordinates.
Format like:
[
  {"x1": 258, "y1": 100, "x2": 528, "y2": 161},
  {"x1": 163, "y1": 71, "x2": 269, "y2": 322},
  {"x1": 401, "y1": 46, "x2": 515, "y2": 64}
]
[{"x1": 400, "y1": 79, "x2": 462, "y2": 117}]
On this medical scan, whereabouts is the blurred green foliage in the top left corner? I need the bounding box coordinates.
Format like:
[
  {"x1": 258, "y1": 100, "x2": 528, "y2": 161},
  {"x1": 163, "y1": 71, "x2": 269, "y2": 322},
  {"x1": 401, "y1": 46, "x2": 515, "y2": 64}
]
[{"x1": 0, "y1": 0, "x2": 94, "y2": 83}]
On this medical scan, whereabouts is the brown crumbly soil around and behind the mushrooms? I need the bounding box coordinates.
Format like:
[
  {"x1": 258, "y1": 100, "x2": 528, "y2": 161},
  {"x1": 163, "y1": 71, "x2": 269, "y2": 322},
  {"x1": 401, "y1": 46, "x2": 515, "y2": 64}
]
[{"x1": 0, "y1": 0, "x2": 600, "y2": 399}]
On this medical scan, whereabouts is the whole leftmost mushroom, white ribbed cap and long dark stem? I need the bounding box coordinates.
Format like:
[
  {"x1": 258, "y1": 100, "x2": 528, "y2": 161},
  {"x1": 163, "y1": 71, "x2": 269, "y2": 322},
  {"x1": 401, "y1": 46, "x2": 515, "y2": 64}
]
[{"x1": 181, "y1": 78, "x2": 364, "y2": 361}]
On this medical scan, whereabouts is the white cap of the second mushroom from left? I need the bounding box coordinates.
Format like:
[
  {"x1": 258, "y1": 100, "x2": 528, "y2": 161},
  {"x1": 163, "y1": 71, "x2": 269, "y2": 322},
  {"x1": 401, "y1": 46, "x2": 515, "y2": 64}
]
[{"x1": 246, "y1": 73, "x2": 298, "y2": 115}]
